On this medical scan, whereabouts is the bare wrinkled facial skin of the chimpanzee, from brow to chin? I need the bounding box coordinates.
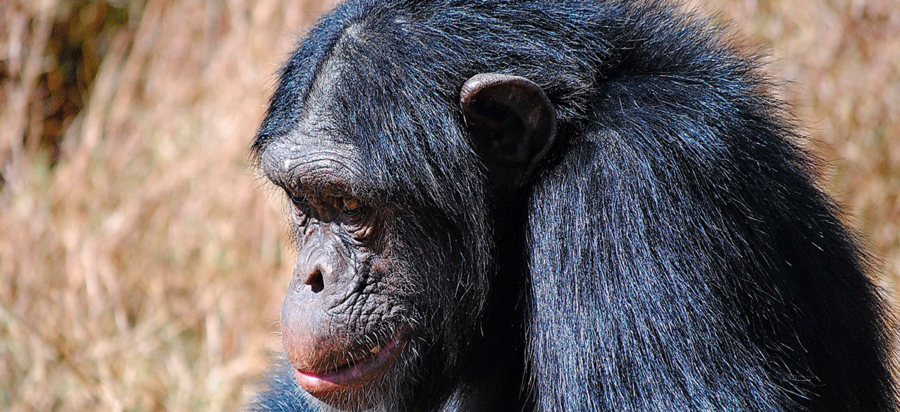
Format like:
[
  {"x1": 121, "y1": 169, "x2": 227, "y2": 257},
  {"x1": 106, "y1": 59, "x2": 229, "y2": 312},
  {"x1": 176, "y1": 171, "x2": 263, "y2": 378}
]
[{"x1": 262, "y1": 135, "x2": 412, "y2": 407}]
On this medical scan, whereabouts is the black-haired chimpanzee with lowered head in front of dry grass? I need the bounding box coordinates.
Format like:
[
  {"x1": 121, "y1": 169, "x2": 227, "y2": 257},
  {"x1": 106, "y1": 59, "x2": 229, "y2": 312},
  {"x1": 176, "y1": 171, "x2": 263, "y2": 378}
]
[{"x1": 250, "y1": 0, "x2": 897, "y2": 412}]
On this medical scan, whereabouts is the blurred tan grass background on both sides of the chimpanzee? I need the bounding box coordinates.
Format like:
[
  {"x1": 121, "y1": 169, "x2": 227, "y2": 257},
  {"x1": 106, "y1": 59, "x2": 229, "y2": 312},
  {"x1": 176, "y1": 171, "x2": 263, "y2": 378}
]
[{"x1": 0, "y1": 0, "x2": 900, "y2": 411}]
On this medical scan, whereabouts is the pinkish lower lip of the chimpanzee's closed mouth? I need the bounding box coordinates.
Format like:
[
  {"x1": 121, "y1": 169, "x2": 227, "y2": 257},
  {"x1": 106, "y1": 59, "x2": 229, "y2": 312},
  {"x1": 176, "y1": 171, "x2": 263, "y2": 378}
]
[{"x1": 294, "y1": 334, "x2": 403, "y2": 397}]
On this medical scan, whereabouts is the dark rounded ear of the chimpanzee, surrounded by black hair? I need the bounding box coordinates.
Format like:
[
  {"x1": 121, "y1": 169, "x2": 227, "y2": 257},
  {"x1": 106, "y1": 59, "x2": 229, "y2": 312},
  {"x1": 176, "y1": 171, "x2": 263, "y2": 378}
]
[{"x1": 459, "y1": 73, "x2": 556, "y2": 187}]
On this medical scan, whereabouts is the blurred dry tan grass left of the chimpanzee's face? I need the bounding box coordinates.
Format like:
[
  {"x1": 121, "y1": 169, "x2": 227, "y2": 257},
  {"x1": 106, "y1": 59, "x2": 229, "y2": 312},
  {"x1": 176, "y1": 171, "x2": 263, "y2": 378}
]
[{"x1": 0, "y1": 0, "x2": 334, "y2": 411}]
